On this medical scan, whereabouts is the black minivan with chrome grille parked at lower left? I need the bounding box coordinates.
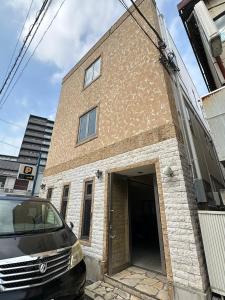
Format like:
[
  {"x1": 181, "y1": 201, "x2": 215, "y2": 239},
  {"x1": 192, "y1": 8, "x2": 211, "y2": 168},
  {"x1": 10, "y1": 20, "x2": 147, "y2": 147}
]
[{"x1": 0, "y1": 196, "x2": 86, "y2": 300}]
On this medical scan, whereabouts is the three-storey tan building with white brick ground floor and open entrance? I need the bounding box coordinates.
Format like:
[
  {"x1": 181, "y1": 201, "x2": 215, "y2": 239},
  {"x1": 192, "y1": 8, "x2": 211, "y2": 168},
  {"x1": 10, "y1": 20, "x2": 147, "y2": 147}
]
[{"x1": 40, "y1": 0, "x2": 224, "y2": 300}]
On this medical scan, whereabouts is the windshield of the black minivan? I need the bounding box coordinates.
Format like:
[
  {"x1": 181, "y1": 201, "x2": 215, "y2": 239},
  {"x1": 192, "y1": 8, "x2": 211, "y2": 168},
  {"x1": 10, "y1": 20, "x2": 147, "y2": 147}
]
[{"x1": 0, "y1": 200, "x2": 63, "y2": 236}]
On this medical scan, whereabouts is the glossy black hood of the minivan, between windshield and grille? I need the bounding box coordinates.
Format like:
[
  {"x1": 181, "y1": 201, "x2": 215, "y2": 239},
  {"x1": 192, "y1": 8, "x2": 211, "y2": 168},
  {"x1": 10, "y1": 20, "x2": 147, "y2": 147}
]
[{"x1": 0, "y1": 228, "x2": 76, "y2": 260}]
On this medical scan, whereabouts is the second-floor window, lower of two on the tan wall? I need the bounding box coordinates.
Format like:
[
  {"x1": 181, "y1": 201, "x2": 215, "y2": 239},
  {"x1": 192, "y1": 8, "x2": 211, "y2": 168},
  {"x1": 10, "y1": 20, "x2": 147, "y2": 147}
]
[{"x1": 78, "y1": 108, "x2": 96, "y2": 142}]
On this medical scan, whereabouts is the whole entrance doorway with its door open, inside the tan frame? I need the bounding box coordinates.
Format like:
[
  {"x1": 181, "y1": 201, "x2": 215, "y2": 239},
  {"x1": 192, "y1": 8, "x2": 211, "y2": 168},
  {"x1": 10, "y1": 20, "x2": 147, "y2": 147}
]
[{"x1": 108, "y1": 166, "x2": 166, "y2": 275}]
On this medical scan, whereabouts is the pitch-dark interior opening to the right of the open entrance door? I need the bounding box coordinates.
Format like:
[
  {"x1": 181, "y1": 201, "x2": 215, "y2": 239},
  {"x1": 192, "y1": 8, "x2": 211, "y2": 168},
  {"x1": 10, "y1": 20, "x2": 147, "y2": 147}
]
[{"x1": 128, "y1": 175, "x2": 162, "y2": 272}]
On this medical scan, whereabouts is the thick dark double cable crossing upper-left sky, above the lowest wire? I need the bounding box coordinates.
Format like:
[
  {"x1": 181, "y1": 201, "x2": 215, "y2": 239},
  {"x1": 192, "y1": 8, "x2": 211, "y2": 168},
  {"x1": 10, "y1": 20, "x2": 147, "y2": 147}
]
[{"x1": 0, "y1": 0, "x2": 48, "y2": 94}]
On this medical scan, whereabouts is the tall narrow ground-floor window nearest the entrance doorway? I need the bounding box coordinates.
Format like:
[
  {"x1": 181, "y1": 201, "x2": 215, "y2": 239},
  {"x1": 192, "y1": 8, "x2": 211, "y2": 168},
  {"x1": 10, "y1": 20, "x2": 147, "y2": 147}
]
[{"x1": 81, "y1": 181, "x2": 93, "y2": 240}]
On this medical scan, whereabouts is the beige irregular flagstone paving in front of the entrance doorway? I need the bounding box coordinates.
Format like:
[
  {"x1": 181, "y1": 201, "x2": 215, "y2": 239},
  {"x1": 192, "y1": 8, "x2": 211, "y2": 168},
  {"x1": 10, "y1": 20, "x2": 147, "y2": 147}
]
[{"x1": 86, "y1": 267, "x2": 169, "y2": 300}]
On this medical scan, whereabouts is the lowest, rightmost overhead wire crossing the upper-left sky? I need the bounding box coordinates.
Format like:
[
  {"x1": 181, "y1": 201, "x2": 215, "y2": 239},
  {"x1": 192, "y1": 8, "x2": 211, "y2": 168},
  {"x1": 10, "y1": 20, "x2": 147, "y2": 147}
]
[{"x1": 0, "y1": 0, "x2": 66, "y2": 109}]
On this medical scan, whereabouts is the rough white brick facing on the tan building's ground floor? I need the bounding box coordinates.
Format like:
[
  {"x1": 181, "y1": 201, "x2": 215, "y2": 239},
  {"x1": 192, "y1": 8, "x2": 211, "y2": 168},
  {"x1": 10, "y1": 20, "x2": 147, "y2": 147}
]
[{"x1": 42, "y1": 138, "x2": 206, "y2": 290}]
